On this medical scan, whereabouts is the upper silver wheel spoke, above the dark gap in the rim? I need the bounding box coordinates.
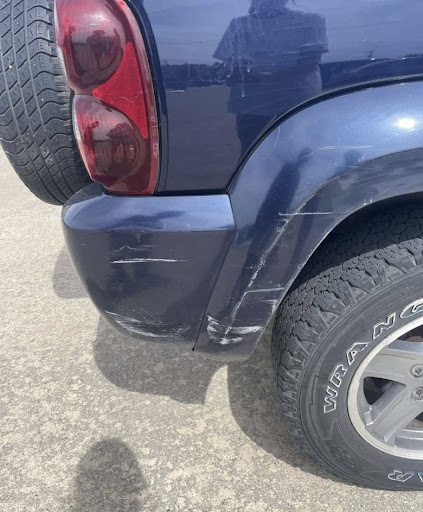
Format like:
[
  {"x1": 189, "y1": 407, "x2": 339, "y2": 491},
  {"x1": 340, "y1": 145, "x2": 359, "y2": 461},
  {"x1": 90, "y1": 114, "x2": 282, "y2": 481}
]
[{"x1": 363, "y1": 340, "x2": 423, "y2": 384}]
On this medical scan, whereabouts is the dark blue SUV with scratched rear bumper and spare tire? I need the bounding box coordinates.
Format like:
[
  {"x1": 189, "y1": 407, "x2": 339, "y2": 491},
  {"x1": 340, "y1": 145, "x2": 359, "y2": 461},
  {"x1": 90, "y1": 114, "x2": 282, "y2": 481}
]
[{"x1": 0, "y1": 0, "x2": 423, "y2": 489}]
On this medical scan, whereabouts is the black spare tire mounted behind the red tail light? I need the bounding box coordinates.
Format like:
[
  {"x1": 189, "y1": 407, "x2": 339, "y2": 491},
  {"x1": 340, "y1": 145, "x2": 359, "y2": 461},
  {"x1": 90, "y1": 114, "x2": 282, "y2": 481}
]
[{"x1": 0, "y1": 0, "x2": 90, "y2": 204}]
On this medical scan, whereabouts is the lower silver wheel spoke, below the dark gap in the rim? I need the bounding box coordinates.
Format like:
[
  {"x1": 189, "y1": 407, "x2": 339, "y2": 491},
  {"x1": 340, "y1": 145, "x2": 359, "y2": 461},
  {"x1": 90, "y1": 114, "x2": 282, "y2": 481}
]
[{"x1": 364, "y1": 382, "x2": 423, "y2": 446}]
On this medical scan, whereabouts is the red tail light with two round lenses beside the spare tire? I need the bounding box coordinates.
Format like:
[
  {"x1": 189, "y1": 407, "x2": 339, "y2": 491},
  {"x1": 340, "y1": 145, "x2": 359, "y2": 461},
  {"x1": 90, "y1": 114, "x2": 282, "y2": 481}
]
[{"x1": 55, "y1": 0, "x2": 159, "y2": 194}]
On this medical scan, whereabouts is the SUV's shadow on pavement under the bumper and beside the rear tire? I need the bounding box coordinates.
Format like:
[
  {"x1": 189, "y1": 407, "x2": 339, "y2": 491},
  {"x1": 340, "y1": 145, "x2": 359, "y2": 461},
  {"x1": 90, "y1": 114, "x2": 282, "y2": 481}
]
[{"x1": 53, "y1": 246, "x2": 338, "y2": 482}]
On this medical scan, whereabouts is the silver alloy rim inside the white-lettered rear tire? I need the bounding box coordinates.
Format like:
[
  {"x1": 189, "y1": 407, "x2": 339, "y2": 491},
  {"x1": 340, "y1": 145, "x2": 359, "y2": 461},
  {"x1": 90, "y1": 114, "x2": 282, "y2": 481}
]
[{"x1": 348, "y1": 318, "x2": 423, "y2": 460}]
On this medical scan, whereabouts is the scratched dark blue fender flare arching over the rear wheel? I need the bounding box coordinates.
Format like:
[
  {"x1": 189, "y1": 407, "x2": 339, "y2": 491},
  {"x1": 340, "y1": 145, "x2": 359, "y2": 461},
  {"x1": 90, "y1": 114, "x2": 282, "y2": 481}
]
[{"x1": 196, "y1": 82, "x2": 423, "y2": 360}]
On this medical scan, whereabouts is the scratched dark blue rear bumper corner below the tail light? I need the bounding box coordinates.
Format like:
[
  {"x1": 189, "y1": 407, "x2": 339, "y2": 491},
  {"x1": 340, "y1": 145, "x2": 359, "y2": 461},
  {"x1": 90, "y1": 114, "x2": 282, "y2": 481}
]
[{"x1": 63, "y1": 184, "x2": 235, "y2": 348}]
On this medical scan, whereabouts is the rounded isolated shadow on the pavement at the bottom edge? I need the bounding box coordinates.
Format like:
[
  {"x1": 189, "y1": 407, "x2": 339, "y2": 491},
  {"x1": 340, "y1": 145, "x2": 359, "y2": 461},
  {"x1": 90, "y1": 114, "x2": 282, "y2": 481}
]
[{"x1": 72, "y1": 439, "x2": 147, "y2": 512}]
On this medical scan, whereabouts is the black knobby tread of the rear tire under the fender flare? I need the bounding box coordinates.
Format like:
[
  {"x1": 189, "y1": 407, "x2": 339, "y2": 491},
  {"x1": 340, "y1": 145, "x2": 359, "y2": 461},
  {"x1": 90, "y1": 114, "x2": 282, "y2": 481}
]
[{"x1": 272, "y1": 208, "x2": 423, "y2": 488}]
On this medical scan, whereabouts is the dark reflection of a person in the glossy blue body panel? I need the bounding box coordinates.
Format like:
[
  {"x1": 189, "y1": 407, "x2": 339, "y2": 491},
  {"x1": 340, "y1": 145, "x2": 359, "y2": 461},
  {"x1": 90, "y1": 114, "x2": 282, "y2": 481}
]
[{"x1": 214, "y1": 0, "x2": 327, "y2": 153}]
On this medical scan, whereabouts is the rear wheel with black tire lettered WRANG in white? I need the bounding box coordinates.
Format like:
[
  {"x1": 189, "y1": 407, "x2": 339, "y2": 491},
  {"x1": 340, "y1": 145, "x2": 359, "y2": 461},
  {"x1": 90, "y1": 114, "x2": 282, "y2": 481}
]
[{"x1": 272, "y1": 209, "x2": 423, "y2": 490}]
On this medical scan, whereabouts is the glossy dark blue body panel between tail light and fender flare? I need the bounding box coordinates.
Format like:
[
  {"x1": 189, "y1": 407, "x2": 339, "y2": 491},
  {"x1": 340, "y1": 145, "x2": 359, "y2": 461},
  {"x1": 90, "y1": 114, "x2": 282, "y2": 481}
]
[{"x1": 132, "y1": 0, "x2": 423, "y2": 192}]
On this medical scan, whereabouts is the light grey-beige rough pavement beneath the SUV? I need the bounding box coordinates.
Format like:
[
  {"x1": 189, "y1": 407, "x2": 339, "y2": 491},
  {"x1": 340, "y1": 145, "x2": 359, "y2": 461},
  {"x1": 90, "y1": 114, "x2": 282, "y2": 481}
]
[{"x1": 0, "y1": 150, "x2": 423, "y2": 512}]
